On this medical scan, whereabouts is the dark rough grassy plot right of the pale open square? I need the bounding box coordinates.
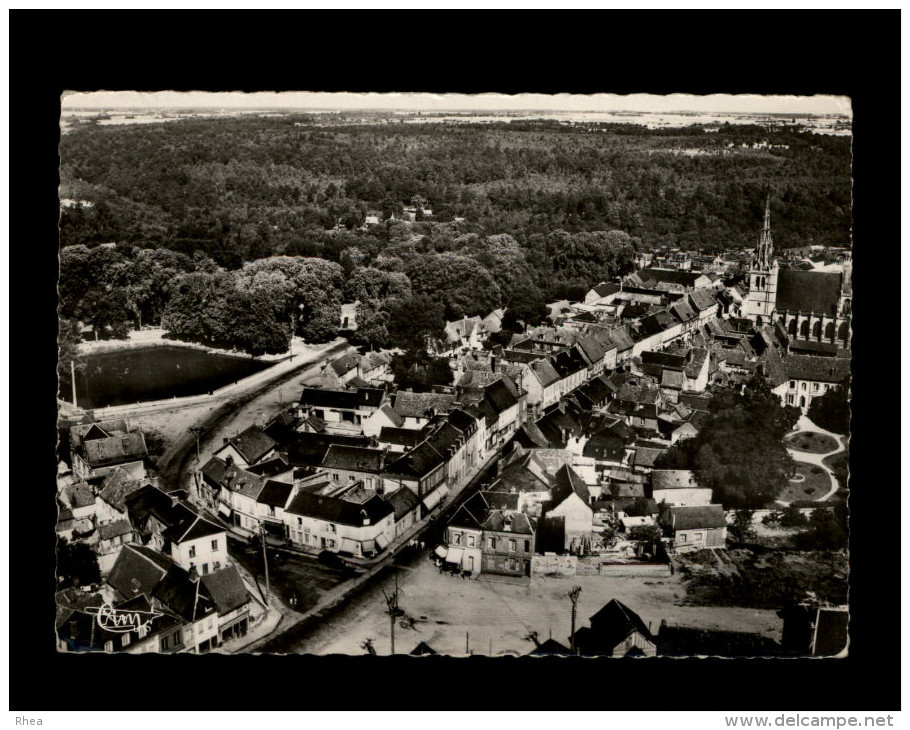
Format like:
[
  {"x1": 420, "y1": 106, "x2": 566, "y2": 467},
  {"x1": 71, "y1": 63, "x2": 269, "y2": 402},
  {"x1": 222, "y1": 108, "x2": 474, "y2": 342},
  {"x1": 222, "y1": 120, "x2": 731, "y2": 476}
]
[{"x1": 680, "y1": 546, "x2": 849, "y2": 609}]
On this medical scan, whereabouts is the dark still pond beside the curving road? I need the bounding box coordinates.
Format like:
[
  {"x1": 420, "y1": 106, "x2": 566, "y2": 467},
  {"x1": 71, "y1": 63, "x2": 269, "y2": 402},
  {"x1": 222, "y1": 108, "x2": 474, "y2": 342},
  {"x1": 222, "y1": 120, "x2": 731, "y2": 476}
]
[{"x1": 60, "y1": 345, "x2": 272, "y2": 408}]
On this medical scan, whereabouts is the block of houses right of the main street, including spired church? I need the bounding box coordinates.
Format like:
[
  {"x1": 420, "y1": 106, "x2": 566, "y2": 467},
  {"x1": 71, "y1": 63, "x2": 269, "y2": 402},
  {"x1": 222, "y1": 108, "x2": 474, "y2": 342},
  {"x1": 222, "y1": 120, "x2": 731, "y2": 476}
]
[{"x1": 430, "y1": 196, "x2": 851, "y2": 575}]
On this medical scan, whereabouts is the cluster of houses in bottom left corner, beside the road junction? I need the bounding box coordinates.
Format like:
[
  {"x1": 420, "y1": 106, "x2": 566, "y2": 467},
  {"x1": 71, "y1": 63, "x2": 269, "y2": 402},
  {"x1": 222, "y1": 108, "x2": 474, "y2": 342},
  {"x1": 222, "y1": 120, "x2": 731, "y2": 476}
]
[{"x1": 56, "y1": 420, "x2": 264, "y2": 653}]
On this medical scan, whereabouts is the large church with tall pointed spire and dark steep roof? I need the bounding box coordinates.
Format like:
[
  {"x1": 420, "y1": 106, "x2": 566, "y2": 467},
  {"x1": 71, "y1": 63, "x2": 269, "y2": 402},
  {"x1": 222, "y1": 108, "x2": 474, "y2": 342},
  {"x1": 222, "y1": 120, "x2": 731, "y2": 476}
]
[{"x1": 742, "y1": 197, "x2": 852, "y2": 355}]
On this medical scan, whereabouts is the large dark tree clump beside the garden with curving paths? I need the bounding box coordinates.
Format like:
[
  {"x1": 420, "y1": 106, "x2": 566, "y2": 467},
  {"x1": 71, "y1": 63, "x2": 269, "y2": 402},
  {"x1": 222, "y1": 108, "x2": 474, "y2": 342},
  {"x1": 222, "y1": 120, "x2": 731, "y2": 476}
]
[{"x1": 658, "y1": 376, "x2": 799, "y2": 509}]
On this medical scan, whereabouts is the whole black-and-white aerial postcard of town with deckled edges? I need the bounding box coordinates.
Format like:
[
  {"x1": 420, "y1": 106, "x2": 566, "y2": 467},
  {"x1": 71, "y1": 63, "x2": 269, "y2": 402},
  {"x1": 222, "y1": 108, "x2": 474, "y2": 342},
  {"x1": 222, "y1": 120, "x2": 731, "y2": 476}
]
[{"x1": 57, "y1": 92, "x2": 859, "y2": 665}]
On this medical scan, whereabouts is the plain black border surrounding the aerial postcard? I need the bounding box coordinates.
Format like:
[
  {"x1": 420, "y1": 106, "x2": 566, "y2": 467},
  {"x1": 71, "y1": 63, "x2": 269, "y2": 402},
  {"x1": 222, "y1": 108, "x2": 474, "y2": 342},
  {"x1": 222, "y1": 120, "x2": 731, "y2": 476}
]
[{"x1": 9, "y1": 10, "x2": 900, "y2": 711}]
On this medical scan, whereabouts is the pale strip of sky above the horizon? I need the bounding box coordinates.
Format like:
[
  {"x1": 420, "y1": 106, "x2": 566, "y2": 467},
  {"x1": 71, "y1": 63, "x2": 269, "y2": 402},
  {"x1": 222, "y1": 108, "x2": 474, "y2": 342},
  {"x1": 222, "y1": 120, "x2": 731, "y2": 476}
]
[{"x1": 62, "y1": 91, "x2": 852, "y2": 116}]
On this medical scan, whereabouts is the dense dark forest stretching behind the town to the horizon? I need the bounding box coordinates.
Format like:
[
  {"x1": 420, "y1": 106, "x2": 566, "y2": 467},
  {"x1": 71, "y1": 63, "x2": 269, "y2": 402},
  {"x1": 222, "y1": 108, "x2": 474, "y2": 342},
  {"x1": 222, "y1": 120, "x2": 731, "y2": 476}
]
[{"x1": 60, "y1": 116, "x2": 851, "y2": 352}]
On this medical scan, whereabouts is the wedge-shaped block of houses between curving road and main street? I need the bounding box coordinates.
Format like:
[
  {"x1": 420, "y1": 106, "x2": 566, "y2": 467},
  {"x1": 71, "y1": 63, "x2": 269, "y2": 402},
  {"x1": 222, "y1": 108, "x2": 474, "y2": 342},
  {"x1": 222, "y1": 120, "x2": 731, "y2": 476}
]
[{"x1": 197, "y1": 370, "x2": 519, "y2": 559}]
